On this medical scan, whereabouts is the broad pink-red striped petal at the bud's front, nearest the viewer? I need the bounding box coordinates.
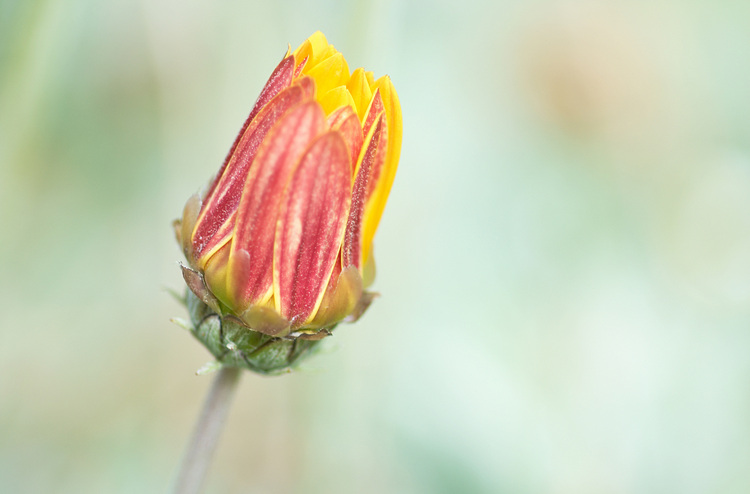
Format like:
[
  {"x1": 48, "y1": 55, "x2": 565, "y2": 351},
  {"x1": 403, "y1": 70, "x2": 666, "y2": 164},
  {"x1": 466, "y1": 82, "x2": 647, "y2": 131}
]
[{"x1": 273, "y1": 131, "x2": 351, "y2": 328}]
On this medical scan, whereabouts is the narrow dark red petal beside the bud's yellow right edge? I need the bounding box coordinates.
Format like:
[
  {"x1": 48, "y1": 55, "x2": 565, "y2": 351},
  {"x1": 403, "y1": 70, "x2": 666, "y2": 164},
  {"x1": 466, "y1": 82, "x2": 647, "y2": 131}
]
[{"x1": 343, "y1": 113, "x2": 385, "y2": 270}]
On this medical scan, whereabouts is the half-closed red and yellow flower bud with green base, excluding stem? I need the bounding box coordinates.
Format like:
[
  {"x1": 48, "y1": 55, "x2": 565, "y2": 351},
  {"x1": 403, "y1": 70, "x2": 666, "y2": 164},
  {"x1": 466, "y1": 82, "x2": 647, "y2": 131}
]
[{"x1": 175, "y1": 32, "x2": 402, "y2": 373}]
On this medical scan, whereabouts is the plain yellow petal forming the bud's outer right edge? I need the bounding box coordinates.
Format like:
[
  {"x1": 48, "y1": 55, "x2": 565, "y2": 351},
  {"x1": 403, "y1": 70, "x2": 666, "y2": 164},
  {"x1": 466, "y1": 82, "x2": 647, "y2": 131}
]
[{"x1": 362, "y1": 76, "x2": 403, "y2": 263}]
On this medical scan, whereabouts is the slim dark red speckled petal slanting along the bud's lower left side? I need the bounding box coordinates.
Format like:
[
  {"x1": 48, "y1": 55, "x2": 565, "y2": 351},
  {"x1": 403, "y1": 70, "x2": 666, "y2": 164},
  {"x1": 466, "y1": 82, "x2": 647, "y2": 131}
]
[{"x1": 192, "y1": 86, "x2": 314, "y2": 263}]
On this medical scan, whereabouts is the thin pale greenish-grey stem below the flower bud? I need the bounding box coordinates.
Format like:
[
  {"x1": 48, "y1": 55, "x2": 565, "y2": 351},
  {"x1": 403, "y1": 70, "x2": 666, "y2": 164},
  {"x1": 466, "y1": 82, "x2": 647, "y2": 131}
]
[{"x1": 173, "y1": 367, "x2": 241, "y2": 494}]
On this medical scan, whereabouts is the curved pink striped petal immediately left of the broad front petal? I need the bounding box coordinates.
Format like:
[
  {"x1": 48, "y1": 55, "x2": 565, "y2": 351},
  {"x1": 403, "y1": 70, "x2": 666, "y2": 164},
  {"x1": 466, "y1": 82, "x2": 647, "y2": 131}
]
[{"x1": 227, "y1": 101, "x2": 326, "y2": 308}]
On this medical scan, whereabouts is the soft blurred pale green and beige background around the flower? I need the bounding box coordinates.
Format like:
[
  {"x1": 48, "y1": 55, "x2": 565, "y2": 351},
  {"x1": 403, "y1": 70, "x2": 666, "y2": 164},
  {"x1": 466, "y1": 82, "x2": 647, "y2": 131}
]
[{"x1": 0, "y1": 0, "x2": 750, "y2": 494}]
